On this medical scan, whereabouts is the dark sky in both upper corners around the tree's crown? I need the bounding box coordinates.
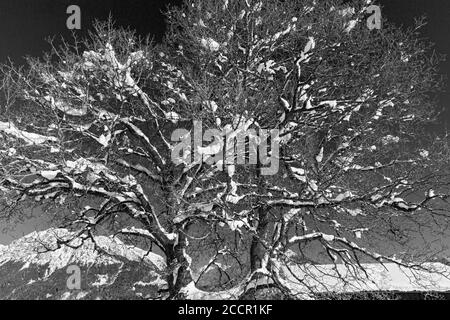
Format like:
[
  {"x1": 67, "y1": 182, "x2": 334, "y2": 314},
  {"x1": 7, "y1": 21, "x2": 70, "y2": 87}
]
[{"x1": 0, "y1": 0, "x2": 450, "y2": 243}]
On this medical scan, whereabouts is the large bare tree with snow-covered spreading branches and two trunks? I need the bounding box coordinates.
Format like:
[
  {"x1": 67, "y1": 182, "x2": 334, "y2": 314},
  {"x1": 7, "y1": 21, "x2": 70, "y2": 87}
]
[{"x1": 0, "y1": 0, "x2": 449, "y2": 298}]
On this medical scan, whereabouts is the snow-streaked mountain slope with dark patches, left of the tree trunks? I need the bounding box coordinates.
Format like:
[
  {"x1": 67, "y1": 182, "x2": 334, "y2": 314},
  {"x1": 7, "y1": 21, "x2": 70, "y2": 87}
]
[{"x1": 0, "y1": 229, "x2": 166, "y2": 299}]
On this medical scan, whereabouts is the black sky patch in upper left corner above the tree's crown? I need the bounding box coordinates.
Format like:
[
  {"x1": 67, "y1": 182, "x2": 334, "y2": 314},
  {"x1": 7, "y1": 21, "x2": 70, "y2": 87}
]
[{"x1": 0, "y1": 0, "x2": 181, "y2": 62}]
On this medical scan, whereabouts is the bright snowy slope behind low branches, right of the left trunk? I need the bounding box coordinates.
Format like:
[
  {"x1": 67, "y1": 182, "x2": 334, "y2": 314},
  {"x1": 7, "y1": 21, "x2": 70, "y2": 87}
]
[{"x1": 184, "y1": 263, "x2": 450, "y2": 300}]
